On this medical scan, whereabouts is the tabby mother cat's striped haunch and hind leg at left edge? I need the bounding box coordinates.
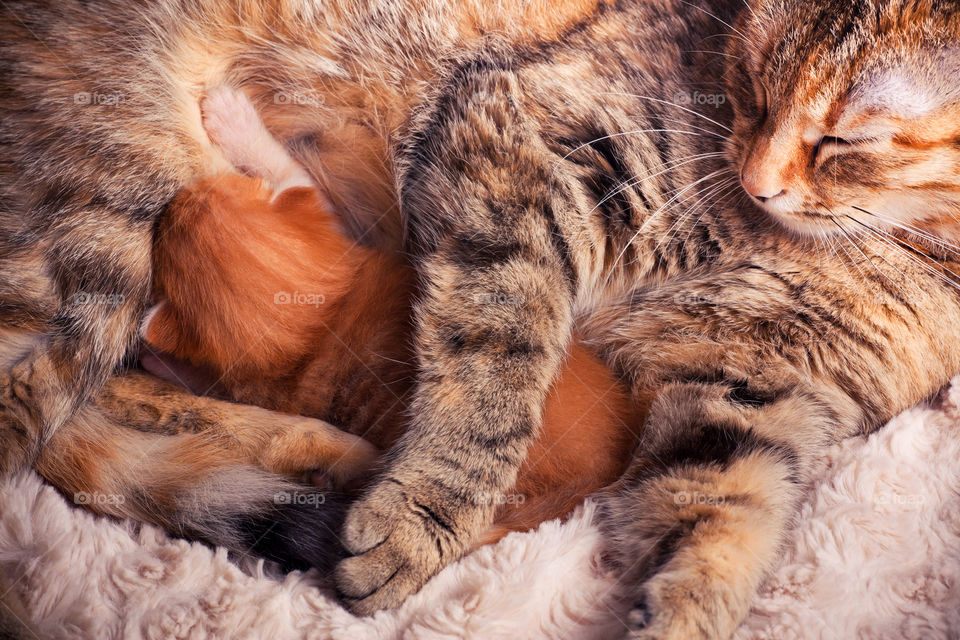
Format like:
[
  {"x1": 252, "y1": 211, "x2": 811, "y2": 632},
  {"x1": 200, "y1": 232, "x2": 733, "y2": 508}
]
[{"x1": 0, "y1": 2, "x2": 202, "y2": 474}]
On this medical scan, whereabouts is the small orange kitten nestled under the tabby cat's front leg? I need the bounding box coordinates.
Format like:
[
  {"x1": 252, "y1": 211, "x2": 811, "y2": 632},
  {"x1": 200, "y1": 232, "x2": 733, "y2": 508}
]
[{"x1": 141, "y1": 88, "x2": 640, "y2": 543}]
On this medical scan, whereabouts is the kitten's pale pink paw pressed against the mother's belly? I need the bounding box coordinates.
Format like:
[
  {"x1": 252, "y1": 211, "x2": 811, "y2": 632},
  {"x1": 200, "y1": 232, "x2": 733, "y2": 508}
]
[{"x1": 200, "y1": 87, "x2": 270, "y2": 169}]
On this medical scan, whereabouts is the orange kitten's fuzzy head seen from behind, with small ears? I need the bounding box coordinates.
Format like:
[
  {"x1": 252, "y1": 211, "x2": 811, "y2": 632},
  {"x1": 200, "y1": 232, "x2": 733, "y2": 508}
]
[{"x1": 145, "y1": 174, "x2": 364, "y2": 379}]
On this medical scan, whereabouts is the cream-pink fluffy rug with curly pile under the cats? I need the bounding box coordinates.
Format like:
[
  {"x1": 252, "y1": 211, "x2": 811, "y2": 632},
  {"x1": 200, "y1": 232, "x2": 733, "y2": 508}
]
[{"x1": 0, "y1": 378, "x2": 960, "y2": 640}]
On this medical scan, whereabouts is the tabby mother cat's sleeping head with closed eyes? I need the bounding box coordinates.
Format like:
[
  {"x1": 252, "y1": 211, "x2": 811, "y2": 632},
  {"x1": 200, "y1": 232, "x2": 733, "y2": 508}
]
[{"x1": 727, "y1": 0, "x2": 960, "y2": 234}]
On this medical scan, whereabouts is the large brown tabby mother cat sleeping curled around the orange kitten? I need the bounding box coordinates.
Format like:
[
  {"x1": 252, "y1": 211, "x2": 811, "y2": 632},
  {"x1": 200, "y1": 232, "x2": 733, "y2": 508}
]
[{"x1": 0, "y1": 0, "x2": 960, "y2": 638}]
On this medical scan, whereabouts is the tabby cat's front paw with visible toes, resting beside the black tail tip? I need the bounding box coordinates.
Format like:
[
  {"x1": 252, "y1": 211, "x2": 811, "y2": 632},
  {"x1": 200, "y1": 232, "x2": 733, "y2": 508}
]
[{"x1": 336, "y1": 475, "x2": 464, "y2": 615}]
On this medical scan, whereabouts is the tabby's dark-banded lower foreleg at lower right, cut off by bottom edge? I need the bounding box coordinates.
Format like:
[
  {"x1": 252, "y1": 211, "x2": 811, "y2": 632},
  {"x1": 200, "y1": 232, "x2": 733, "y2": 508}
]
[{"x1": 602, "y1": 383, "x2": 831, "y2": 639}]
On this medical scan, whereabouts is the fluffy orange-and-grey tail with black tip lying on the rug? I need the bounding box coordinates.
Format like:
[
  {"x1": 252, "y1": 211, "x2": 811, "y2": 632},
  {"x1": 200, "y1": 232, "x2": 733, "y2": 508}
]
[{"x1": 35, "y1": 406, "x2": 347, "y2": 572}]
